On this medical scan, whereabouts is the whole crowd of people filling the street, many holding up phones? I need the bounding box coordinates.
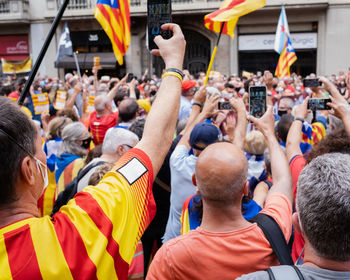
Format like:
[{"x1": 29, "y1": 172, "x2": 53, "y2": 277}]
[{"x1": 0, "y1": 24, "x2": 350, "y2": 279}]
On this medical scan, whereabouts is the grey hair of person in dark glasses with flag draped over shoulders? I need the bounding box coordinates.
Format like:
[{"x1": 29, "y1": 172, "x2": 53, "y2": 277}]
[{"x1": 58, "y1": 122, "x2": 89, "y2": 157}]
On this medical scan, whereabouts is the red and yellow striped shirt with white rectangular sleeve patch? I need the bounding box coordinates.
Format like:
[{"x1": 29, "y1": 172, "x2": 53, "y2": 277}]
[{"x1": 0, "y1": 149, "x2": 155, "y2": 279}]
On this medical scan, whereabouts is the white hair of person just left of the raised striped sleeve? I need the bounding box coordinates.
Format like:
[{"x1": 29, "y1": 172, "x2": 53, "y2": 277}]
[{"x1": 102, "y1": 127, "x2": 139, "y2": 154}]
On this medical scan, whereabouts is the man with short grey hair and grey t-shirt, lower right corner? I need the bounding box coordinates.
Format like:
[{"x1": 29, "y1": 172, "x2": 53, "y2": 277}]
[{"x1": 239, "y1": 153, "x2": 350, "y2": 280}]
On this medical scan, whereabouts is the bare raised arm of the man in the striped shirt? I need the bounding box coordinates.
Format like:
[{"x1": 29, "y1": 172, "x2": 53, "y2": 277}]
[{"x1": 136, "y1": 23, "x2": 186, "y2": 176}]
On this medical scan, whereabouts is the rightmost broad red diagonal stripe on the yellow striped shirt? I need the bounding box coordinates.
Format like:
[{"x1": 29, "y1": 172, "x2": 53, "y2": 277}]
[{"x1": 75, "y1": 192, "x2": 133, "y2": 279}]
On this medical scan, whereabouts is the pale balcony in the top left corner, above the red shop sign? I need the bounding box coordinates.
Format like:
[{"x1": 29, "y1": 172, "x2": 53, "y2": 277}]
[{"x1": 0, "y1": 0, "x2": 29, "y2": 23}]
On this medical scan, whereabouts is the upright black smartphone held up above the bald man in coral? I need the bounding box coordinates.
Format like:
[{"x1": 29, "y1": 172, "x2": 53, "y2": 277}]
[{"x1": 249, "y1": 86, "x2": 267, "y2": 118}]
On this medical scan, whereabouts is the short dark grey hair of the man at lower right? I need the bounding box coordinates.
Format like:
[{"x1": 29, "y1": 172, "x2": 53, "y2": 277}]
[{"x1": 296, "y1": 153, "x2": 350, "y2": 262}]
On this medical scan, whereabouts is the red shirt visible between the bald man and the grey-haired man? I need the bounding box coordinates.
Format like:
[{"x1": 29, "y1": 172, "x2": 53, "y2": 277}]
[{"x1": 289, "y1": 155, "x2": 306, "y2": 261}]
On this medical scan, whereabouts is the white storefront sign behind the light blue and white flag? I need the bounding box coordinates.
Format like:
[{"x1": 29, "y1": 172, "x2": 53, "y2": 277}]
[{"x1": 238, "y1": 33, "x2": 317, "y2": 51}]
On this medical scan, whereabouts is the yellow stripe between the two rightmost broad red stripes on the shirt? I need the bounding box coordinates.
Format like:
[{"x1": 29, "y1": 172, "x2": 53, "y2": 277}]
[{"x1": 62, "y1": 200, "x2": 118, "y2": 280}]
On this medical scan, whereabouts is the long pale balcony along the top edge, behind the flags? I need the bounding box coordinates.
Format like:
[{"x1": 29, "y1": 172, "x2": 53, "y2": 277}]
[{"x1": 45, "y1": 0, "x2": 223, "y2": 18}]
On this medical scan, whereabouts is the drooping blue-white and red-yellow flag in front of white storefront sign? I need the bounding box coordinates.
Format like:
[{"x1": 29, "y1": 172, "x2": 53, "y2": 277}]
[{"x1": 275, "y1": 6, "x2": 297, "y2": 78}]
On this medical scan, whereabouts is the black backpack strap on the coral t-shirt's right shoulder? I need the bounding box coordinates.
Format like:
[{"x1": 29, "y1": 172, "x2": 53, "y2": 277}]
[{"x1": 249, "y1": 213, "x2": 294, "y2": 265}]
